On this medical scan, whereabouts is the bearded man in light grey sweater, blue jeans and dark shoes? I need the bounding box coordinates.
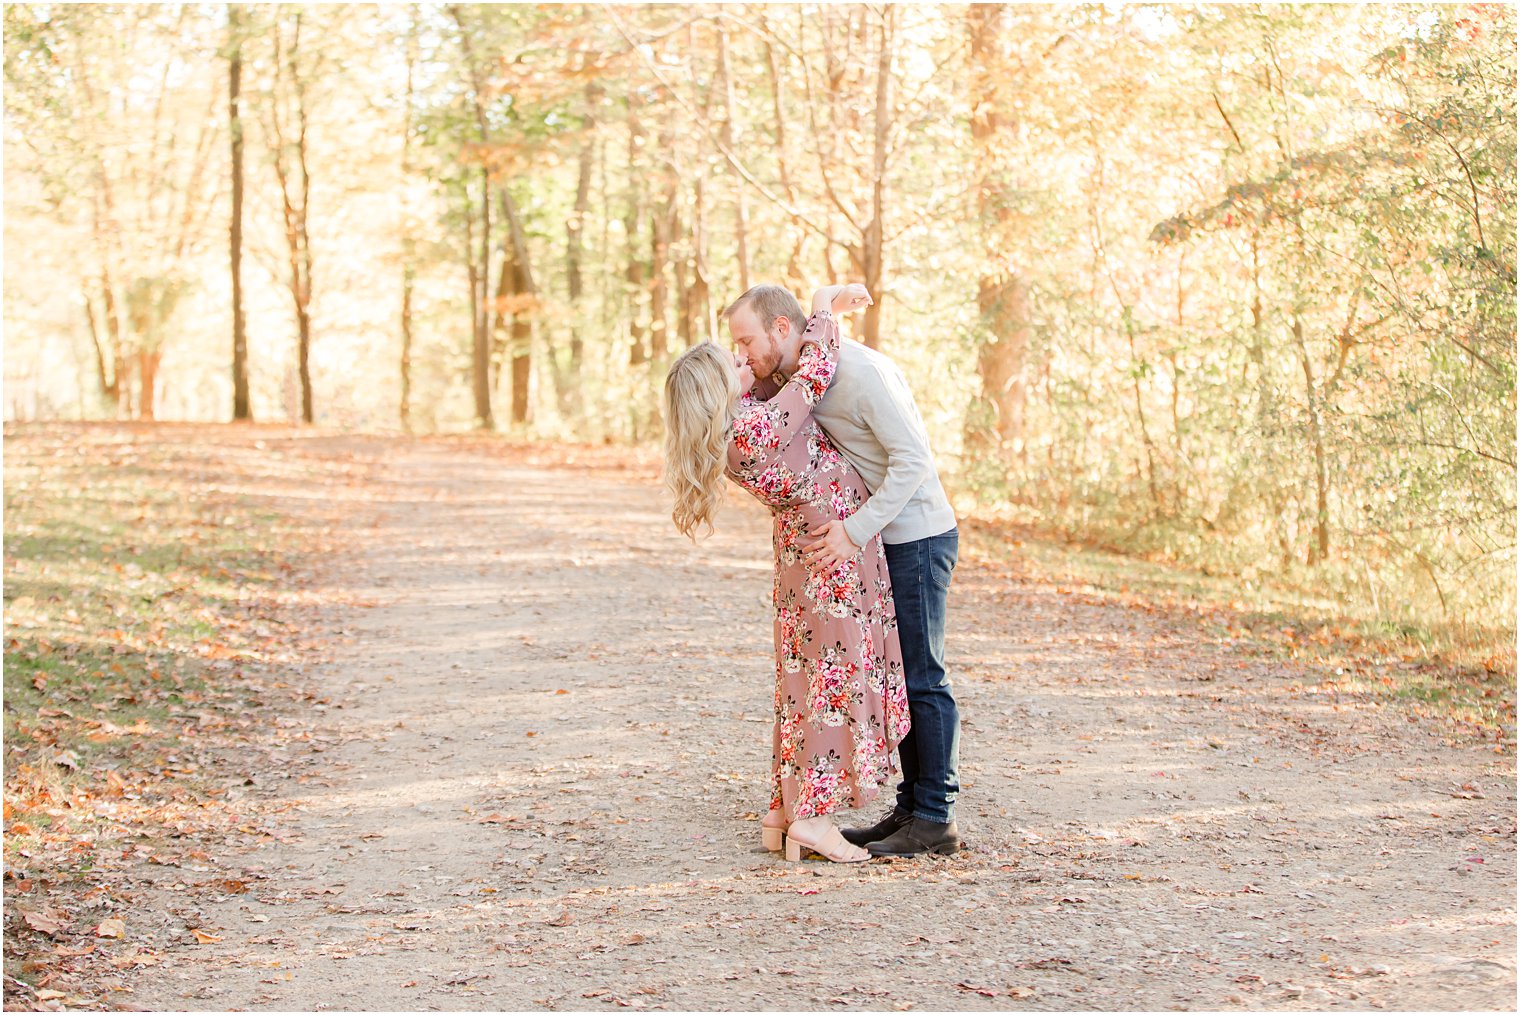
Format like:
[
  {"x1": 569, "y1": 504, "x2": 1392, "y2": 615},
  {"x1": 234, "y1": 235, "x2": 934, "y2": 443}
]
[{"x1": 724, "y1": 286, "x2": 961, "y2": 857}]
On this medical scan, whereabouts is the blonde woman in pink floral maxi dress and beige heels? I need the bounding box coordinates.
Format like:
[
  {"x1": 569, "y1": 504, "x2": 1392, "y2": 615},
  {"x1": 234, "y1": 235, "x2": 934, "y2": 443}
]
[{"x1": 664, "y1": 286, "x2": 909, "y2": 863}]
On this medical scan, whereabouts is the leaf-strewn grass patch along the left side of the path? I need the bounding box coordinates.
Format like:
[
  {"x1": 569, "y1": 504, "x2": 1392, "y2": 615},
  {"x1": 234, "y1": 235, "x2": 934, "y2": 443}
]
[{"x1": 5, "y1": 425, "x2": 317, "y2": 1000}]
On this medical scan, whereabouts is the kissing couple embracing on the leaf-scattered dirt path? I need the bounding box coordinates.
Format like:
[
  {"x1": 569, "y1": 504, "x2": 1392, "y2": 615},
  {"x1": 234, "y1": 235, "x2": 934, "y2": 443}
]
[{"x1": 664, "y1": 284, "x2": 961, "y2": 863}]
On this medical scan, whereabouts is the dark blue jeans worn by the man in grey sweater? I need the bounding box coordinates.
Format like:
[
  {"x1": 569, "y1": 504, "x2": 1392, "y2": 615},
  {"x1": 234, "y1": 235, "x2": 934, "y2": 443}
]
[{"x1": 886, "y1": 529, "x2": 961, "y2": 825}]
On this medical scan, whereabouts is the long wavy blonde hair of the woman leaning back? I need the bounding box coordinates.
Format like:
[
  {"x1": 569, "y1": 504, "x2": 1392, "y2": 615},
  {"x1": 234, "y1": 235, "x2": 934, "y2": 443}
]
[{"x1": 664, "y1": 342, "x2": 739, "y2": 542}]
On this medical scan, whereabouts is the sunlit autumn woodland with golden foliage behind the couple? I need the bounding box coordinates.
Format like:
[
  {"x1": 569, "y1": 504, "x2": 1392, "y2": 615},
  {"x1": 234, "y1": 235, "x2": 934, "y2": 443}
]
[{"x1": 5, "y1": 5, "x2": 1515, "y2": 673}]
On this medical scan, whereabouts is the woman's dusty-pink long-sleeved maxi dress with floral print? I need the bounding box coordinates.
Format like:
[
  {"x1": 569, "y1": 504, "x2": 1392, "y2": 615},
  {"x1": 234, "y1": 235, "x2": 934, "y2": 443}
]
[{"x1": 728, "y1": 311, "x2": 909, "y2": 821}]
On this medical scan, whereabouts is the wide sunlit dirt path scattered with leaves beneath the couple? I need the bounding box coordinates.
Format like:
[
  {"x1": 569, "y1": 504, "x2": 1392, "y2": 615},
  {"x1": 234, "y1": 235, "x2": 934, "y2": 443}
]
[{"x1": 131, "y1": 439, "x2": 1515, "y2": 1010}]
